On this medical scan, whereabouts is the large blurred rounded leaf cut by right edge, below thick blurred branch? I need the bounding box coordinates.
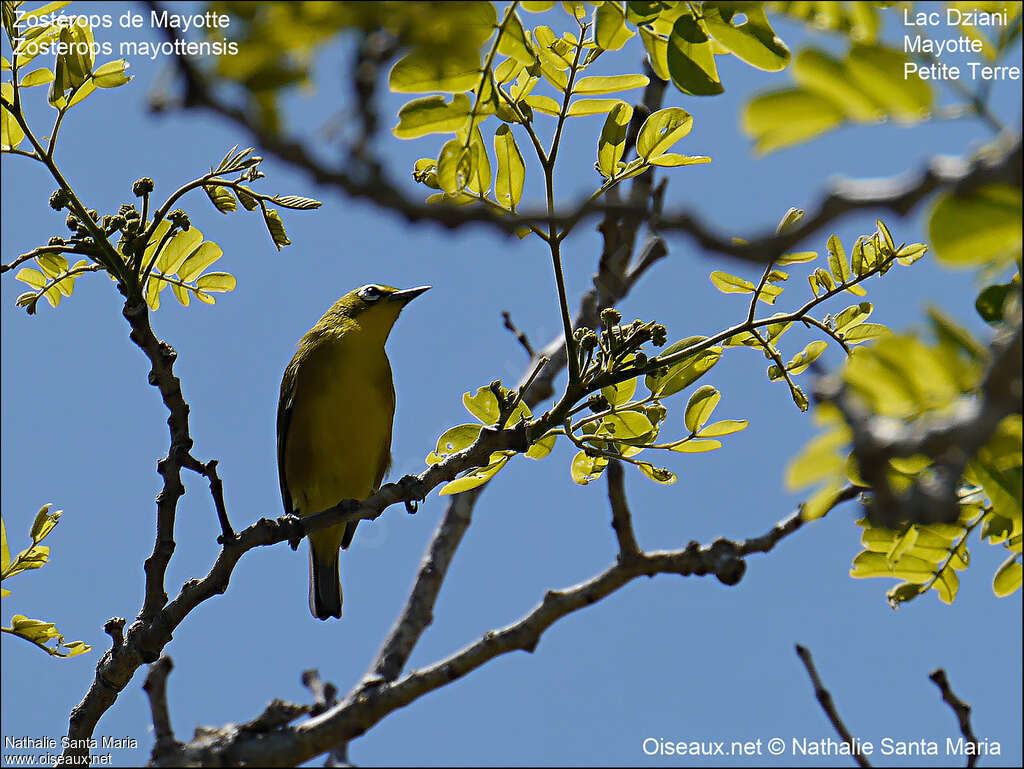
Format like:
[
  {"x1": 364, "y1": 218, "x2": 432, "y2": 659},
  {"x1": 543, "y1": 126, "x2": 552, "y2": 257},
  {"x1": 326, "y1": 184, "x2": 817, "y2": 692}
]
[{"x1": 928, "y1": 184, "x2": 1021, "y2": 267}]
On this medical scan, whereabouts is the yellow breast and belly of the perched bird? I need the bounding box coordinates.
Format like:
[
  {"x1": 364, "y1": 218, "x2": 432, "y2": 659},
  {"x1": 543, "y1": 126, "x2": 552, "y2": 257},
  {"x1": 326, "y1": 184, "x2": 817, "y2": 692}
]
[{"x1": 284, "y1": 334, "x2": 394, "y2": 528}]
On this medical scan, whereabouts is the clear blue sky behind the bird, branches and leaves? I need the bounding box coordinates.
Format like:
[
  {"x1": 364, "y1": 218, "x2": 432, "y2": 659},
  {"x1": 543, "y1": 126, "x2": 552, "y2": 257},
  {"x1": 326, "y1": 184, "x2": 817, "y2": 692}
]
[{"x1": 0, "y1": 3, "x2": 1021, "y2": 766}]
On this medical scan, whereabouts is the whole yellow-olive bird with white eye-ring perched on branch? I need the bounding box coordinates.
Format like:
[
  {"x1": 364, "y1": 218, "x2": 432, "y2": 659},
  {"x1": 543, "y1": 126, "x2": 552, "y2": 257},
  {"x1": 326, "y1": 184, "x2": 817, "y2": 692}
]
[{"x1": 278, "y1": 284, "x2": 430, "y2": 620}]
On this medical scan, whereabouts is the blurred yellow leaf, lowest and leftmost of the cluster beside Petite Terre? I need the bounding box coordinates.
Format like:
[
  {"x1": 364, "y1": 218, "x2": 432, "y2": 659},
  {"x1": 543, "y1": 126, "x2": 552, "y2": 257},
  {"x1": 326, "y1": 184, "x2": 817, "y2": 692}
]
[{"x1": 740, "y1": 88, "x2": 844, "y2": 154}]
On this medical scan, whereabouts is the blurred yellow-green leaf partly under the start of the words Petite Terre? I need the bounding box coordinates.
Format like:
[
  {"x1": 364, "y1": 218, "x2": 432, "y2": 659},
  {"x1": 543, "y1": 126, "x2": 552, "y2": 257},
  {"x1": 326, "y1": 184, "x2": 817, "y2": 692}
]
[{"x1": 846, "y1": 45, "x2": 934, "y2": 123}]
